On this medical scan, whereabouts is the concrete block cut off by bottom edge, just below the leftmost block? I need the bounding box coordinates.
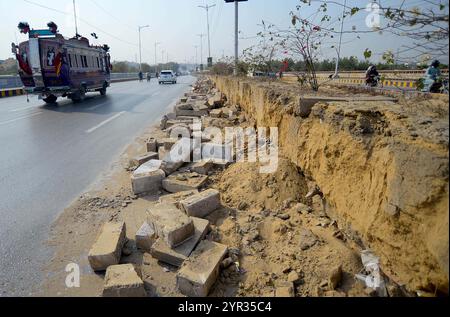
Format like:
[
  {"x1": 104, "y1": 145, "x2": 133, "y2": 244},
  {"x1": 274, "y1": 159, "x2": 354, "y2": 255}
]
[{"x1": 103, "y1": 264, "x2": 147, "y2": 297}]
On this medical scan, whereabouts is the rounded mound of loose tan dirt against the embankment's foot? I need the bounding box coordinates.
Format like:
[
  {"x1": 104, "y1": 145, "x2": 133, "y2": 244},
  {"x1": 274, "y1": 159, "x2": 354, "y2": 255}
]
[{"x1": 219, "y1": 158, "x2": 308, "y2": 211}]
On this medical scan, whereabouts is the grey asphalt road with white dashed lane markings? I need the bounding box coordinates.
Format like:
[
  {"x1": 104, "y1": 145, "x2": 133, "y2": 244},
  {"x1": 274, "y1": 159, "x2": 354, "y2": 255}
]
[{"x1": 0, "y1": 77, "x2": 194, "y2": 297}]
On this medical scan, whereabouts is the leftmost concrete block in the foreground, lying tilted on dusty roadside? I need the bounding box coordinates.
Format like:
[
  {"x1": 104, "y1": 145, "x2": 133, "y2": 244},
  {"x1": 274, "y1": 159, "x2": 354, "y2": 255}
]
[{"x1": 88, "y1": 222, "x2": 126, "y2": 272}]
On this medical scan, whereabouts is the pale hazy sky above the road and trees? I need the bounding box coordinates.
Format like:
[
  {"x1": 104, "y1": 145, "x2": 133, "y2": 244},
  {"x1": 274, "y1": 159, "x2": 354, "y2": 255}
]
[{"x1": 0, "y1": 0, "x2": 448, "y2": 64}]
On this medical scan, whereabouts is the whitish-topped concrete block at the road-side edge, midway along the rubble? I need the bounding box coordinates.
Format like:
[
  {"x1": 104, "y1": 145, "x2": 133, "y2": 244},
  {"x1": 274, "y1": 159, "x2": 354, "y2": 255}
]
[{"x1": 131, "y1": 160, "x2": 166, "y2": 195}]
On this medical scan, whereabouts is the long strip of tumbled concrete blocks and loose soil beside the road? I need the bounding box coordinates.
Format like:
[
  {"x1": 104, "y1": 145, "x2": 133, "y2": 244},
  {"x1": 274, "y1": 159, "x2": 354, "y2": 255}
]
[{"x1": 43, "y1": 74, "x2": 446, "y2": 297}]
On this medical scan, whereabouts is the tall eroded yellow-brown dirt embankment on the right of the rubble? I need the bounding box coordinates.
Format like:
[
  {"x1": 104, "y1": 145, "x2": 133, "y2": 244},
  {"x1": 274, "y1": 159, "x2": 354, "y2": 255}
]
[{"x1": 213, "y1": 77, "x2": 449, "y2": 293}]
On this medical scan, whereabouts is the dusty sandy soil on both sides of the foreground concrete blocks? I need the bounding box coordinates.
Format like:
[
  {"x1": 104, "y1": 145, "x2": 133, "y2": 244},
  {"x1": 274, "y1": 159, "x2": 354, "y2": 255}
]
[{"x1": 35, "y1": 76, "x2": 442, "y2": 297}]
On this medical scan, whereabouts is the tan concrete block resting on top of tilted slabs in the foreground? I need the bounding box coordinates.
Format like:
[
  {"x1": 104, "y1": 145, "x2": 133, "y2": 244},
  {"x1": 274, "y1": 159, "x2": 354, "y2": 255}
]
[{"x1": 147, "y1": 203, "x2": 195, "y2": 248}]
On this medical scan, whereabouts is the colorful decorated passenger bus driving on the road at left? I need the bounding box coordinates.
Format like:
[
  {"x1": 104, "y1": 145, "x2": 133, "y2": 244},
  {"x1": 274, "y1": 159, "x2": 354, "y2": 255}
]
[{"x1": 12, "y1": 22, "x2": 111, "y2": 103}]
